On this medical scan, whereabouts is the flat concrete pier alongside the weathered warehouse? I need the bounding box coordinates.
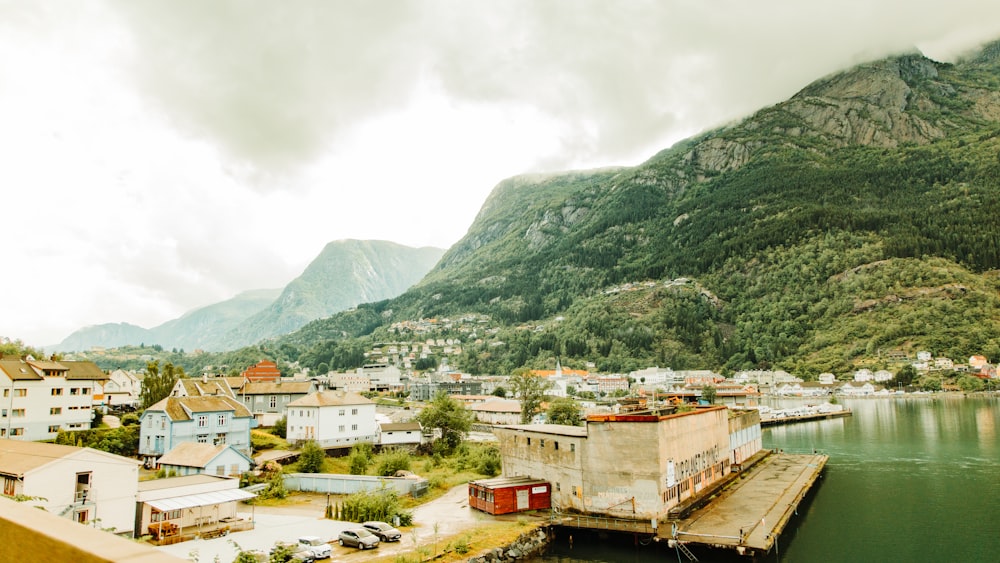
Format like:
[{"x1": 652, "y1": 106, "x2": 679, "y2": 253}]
[{"x1": 657, "y1": 453, "x2": 828, "y2": 555}]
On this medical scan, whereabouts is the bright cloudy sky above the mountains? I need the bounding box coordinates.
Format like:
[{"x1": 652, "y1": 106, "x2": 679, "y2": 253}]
[{"x1": 0, "y1": 0, "x2": 1000, "y2": 347}]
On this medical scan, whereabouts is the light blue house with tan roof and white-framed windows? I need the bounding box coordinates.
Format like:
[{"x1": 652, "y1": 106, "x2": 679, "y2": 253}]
[{"x1": 139, "y1": 395, "x2": 257, "y2": 465}]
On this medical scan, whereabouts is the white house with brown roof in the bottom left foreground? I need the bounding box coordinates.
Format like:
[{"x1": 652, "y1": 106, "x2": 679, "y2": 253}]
[{"x1": 0, "y1": 440, "x2": 139, "y2": 535}]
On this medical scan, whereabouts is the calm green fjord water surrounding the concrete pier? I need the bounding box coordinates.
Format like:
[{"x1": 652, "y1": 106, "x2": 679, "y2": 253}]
[{"x1": 538, "y1": 395, "x2": 1000, "y2": 563}]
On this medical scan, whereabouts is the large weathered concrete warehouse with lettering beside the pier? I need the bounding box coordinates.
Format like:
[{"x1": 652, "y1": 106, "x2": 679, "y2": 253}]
[{"x1": 494, "y1": 406, "x2": 744, "y2": 519}]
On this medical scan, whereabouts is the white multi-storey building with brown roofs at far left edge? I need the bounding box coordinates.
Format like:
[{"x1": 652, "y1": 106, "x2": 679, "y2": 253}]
[{"x1": 0, "y1": 357, "x2": 101, "y2": 441}]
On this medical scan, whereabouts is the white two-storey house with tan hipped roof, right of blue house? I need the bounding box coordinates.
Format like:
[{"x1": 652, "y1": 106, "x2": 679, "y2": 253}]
[{"x1": 285, "y1": 391, "x2": 378, "y2": 447}]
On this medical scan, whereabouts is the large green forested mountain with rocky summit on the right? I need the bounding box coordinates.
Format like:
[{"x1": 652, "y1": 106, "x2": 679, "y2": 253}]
[{"x1": 279, "y1": 44, "x2": 1000, "y2": 376}]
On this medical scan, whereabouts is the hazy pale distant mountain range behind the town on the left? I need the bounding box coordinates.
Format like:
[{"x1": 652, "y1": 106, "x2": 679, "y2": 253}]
[{"x1": 54, "y1": 240, "x2": 444, "y2": 351}]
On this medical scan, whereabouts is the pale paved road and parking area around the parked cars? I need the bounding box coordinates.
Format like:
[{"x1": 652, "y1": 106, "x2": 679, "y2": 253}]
[{"x1": 156, "y1": 485, "x2": 493, "y2": 563}]
